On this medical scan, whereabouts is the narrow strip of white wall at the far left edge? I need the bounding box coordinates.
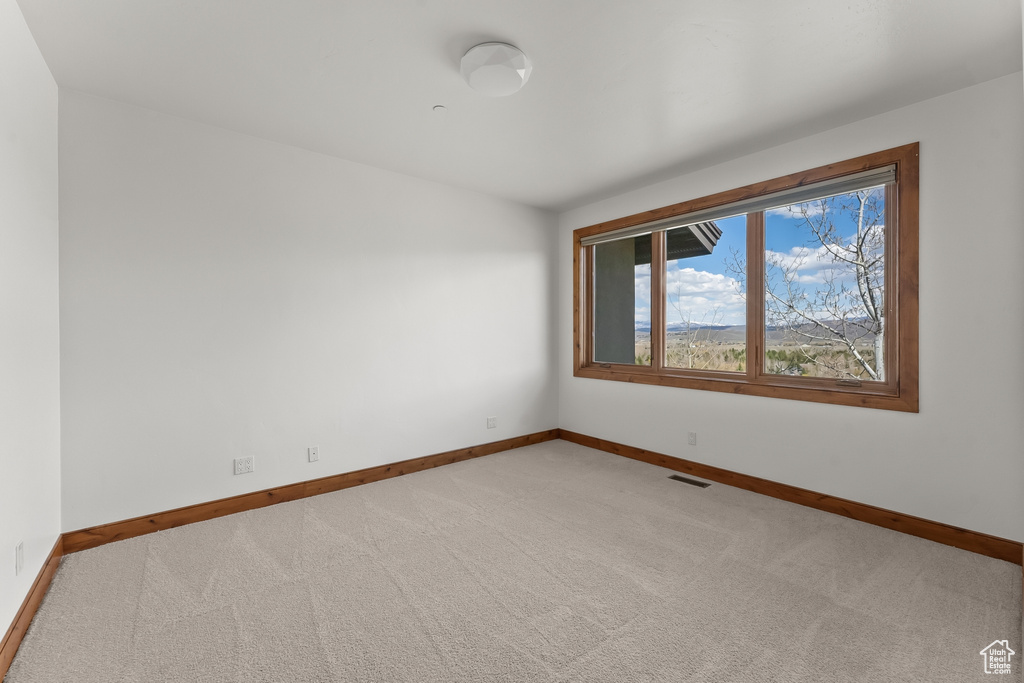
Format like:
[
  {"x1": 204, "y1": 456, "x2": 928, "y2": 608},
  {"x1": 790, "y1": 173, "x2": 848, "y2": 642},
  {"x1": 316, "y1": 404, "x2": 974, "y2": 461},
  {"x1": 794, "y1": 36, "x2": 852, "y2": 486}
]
[{"x1": 0, "y1": 0, "x2": 60, "y2": 636}]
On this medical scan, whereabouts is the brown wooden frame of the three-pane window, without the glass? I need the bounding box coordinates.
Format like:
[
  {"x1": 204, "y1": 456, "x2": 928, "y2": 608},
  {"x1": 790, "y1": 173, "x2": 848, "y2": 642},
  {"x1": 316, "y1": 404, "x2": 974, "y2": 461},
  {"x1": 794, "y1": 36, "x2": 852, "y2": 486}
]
[{"x1": 572, "y1": 142, "x2": 920, "y2": 413}]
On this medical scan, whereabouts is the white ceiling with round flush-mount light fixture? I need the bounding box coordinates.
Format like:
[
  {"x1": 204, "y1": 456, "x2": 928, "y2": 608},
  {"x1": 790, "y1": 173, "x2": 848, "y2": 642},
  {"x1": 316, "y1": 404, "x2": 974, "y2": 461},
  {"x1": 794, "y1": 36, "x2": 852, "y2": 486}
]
[{"x1": 18, "y1": 0, "x2": 1022, "y2": 209}]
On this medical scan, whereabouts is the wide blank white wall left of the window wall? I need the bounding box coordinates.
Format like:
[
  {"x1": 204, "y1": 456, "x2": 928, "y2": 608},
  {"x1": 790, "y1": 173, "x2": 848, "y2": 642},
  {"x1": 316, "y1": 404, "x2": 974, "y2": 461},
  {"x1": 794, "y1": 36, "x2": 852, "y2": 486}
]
[{"x1": 60, "y1": 89, "x2": 557, "y2": 530}]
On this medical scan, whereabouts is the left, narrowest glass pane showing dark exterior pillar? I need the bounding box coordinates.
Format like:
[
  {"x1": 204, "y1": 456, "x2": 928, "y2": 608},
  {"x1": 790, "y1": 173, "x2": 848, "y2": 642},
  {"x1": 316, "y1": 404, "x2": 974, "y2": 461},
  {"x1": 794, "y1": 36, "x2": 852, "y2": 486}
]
[{"x1": 594, "y1": 234, "x2": 650, "y2": 366}]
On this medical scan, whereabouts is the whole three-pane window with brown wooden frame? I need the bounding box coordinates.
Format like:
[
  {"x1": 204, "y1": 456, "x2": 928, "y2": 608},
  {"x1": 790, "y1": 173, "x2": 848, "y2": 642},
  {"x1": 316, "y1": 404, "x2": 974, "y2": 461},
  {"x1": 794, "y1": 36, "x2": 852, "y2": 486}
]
[{"x1": 573, "y1": 143, "x2": 919, "y2": 412}]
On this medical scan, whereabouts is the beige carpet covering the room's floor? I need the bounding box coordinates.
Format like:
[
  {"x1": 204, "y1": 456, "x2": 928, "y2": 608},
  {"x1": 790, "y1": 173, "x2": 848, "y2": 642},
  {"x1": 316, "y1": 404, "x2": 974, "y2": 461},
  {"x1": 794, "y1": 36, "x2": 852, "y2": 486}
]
[{"x1": 7, "y1": 441, "x2": 1024, "y2": 683}]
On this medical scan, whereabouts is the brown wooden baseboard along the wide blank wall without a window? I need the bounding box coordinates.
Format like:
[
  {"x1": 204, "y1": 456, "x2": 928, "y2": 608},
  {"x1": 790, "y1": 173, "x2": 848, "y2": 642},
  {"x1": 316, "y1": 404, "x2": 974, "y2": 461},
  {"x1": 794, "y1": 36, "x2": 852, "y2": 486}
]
[{"x1": 63, "y1": 429, "x2": 558, "y2": 553}]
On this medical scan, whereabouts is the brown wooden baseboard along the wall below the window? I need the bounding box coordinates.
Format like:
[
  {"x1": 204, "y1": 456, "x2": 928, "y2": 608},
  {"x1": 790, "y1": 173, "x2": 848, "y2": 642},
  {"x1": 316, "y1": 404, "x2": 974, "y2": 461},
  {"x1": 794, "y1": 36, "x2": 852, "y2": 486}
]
[{"x1": 559, "y1": 429, "x2": 1024, "y2": 565}]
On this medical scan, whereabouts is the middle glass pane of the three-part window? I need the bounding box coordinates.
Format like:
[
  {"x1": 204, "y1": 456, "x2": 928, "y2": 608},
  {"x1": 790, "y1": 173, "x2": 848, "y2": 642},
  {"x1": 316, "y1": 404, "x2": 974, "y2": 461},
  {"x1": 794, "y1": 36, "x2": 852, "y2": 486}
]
[{"x1": 665, "y1": 216, "x2": 746, "y2": 372}]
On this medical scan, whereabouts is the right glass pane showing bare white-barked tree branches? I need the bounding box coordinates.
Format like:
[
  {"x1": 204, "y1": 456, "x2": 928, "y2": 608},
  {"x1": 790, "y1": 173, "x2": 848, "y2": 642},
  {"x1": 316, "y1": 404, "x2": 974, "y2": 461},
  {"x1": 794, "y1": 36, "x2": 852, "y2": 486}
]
[{"x1": 764, "y1": 185, "x2": 886, "y2": 381}]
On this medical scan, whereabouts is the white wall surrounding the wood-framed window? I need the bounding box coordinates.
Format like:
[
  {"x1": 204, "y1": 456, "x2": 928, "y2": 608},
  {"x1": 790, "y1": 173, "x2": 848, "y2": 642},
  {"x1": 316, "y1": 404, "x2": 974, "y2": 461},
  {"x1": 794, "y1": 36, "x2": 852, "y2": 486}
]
[{"x1": 558, "y1": 74, "x2": 1024, "y2": 541}]
